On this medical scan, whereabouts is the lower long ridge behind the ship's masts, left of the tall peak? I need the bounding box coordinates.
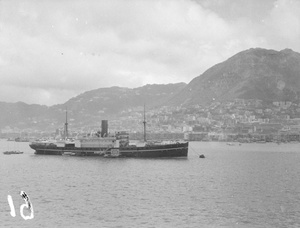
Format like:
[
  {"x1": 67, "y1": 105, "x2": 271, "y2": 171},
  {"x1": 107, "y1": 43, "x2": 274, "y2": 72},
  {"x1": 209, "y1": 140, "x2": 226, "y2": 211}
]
[{"x1": 51, "y1": 83, "x2": 186, "y2": 125}]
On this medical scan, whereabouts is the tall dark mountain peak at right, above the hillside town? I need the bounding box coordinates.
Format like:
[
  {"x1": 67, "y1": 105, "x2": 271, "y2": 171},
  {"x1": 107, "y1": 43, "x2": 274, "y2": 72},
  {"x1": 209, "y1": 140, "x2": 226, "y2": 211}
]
[{"x1": 169, "y1": 48, "x2": 300, "y2": 105}]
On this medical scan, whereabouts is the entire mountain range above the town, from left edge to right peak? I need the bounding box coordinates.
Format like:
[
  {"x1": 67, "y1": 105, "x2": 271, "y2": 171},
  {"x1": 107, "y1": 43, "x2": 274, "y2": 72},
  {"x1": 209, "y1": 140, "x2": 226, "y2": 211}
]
[{"x1": 0, "y1": 48, "x2": 300, "y2": 131}]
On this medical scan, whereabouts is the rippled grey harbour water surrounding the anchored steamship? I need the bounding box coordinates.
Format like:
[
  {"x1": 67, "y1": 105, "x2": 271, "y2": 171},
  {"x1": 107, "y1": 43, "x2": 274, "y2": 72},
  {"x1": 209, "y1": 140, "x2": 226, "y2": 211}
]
[{"x1": 0, "y1": 141, "x2": 300, "y2": 228}]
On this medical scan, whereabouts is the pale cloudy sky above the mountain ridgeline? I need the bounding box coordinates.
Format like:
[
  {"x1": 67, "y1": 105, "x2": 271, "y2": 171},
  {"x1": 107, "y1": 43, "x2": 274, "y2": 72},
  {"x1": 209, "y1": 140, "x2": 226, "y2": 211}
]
[{"x1": 0, "y1": 0, "x2": 300, "y2": 105}]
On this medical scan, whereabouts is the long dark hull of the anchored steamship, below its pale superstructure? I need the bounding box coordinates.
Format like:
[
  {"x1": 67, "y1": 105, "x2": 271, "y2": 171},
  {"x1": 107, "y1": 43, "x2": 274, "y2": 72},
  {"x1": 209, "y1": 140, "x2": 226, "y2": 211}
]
[{"x1": 30, "y1": 142, "x2": 188, "y2": 158}]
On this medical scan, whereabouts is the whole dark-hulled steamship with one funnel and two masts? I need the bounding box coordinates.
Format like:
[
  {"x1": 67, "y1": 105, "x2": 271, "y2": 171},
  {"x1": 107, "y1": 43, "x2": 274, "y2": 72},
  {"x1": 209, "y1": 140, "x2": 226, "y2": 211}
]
[{"x1": 29, "y1": 111, "x2": 188, "y2": 158}]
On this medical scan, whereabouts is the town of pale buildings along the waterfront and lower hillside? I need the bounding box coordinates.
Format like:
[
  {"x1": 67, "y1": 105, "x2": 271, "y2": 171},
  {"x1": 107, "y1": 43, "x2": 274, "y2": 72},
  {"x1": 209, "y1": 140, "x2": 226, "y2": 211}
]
[{"x1": 1, "y1": 99, "x2": 300, "y2": 143}]
